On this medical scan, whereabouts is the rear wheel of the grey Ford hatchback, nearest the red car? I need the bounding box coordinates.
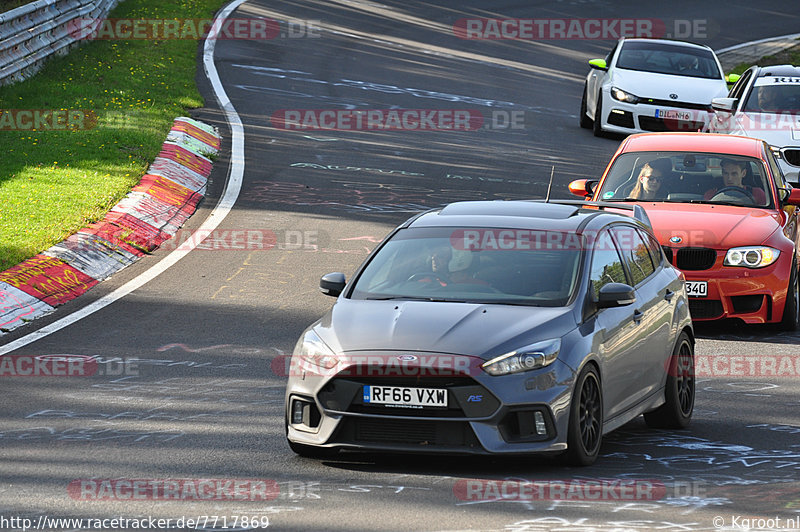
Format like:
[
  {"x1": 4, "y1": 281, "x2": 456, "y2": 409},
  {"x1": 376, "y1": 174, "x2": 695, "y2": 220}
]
[{"x1": 644, "y1": 332, "x2": 695, "y2": 429}]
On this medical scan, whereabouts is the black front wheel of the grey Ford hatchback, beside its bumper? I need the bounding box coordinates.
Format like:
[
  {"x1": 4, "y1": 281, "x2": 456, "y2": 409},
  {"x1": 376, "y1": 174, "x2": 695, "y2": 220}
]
[{"x1": 565, "y1": 364, "x2": 603, "y2": 466}]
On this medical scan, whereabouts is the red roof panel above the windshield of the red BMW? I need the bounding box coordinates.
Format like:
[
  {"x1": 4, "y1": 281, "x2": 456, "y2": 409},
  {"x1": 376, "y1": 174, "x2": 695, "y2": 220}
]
[{"x1": 621, "y1": 132, "x2": 764, "y2": 158}]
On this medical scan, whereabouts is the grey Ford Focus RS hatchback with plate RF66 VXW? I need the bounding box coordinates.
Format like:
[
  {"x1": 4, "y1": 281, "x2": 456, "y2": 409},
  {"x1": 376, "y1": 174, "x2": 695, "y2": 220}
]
[{"x1": 285, "y1": 201, "x2": 695, "y2": 465}]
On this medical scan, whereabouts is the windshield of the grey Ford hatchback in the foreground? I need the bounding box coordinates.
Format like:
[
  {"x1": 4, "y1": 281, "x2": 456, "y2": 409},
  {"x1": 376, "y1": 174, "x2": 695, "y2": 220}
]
[{"x1": 350, "y1": 227, "x2": 584, "y2": 307}]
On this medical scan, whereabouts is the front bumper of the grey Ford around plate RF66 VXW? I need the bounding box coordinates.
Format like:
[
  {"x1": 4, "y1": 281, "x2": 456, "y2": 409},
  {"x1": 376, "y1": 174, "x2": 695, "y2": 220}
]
[{"x1": 286, "y1": 357, "x2": 575, "y2": 454}]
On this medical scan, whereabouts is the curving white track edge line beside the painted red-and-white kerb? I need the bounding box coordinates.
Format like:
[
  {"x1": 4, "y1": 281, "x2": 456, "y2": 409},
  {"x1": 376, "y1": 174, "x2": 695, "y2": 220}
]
[{"x1": 0, "y1": 0, "x2": 247, "y2": 356}]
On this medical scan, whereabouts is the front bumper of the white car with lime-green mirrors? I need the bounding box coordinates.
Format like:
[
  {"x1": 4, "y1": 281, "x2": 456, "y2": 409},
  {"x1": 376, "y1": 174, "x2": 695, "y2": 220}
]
[{"x1": 601, "y1": 92, "x2": 710, "y2": 134}]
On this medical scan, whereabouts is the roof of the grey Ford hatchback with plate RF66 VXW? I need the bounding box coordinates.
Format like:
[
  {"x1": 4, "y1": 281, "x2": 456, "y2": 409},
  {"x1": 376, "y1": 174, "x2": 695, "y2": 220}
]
[{"x1": 408, "y1": 200, "x2": 638, "y2": 233}]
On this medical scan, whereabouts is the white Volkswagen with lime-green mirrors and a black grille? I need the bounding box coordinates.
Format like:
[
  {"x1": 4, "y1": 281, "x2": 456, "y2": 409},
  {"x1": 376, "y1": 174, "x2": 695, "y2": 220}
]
[{"x1": 580, "y1": 39, "x2": 728, "y2": 136}]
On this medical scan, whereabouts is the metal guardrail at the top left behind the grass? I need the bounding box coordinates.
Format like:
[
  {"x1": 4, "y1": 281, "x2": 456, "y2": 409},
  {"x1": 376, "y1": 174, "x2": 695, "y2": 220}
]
[{"x1": 0, "y1": 0, "x2": 119, "y2": 85}]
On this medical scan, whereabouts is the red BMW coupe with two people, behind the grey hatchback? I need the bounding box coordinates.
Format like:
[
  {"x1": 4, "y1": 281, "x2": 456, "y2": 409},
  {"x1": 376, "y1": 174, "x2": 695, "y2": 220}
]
[{"x1": 569, "y1": 133, "x2": 800, "y2": 330}]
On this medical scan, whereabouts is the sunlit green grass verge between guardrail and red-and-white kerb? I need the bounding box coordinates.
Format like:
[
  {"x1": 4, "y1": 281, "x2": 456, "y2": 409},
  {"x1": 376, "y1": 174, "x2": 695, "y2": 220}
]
[{"x1": 0, "y1": 0, "x2": 223, "y2": 271}]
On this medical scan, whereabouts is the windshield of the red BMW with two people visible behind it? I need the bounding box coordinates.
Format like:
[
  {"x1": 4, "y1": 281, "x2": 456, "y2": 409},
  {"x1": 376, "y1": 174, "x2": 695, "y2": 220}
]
[{"x1": 598, "y1": 152, "x2": 772, "y2": 207}]
